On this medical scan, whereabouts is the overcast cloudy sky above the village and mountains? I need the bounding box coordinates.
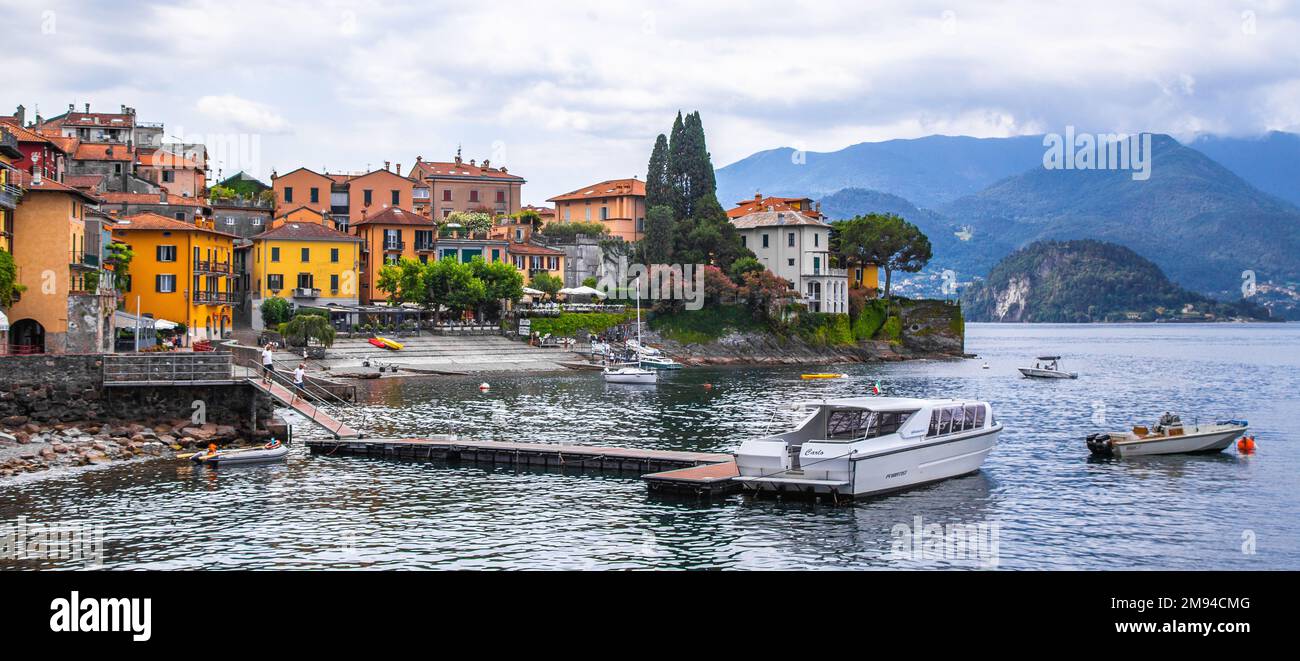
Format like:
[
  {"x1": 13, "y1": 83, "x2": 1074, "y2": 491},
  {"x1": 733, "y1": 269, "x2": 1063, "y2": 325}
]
[{"x1": 0, "y1": 0, "x2": 1300, "y2": 203}]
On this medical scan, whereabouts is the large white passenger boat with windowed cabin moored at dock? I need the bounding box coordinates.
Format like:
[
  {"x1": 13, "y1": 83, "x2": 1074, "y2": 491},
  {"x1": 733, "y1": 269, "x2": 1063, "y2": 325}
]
[{"x1": 736, "y1": 397, "x2": 1002, "y2": 496}]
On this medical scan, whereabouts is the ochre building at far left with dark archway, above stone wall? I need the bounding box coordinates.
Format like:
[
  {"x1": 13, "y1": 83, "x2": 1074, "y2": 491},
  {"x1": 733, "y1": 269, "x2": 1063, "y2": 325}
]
[{"x1": 5, "y1": 176, "x2": 116, "y2": 353}]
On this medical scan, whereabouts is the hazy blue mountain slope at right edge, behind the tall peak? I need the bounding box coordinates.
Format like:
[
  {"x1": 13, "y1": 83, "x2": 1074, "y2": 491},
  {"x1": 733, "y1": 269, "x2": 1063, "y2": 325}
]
[{"x1": 1188, "y1": 131, "x2": 1300, "y2": 206}]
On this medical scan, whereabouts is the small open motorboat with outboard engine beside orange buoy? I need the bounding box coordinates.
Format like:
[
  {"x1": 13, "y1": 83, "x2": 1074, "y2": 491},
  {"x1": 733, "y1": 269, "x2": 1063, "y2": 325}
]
[{"x1": 1087, "y1": 412, "x2": 1248, "y2": 458}]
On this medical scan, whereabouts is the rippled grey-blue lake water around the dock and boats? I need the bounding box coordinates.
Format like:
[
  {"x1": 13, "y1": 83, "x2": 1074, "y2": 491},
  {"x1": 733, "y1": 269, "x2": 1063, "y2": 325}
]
[{"x1": 0, "y1": 324, "x2": 1300, "y2": 569}]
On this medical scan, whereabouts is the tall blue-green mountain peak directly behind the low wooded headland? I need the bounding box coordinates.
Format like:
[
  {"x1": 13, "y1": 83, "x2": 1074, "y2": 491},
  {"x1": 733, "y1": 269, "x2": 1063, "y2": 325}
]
[{"x1": 936, "y1": 135, "x2": 1300, "y2": 298}]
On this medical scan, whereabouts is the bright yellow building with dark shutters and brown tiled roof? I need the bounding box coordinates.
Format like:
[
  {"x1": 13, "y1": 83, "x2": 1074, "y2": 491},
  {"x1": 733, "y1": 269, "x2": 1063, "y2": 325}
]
[{"x1": 251, "y1": 217, "x2": 363, "y2": 331}]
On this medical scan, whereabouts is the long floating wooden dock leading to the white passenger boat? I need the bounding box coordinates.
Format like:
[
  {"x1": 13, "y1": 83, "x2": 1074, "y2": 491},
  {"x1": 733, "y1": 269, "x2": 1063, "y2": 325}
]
[{"x1": 307, "y1": 436, "x2": 740, "y2": 497}]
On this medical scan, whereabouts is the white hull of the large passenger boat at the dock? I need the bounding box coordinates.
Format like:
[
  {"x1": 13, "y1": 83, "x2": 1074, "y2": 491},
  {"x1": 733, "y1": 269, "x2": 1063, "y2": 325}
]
[{"x1": 737, "y1": 425, "x2": 1002, "y2": 497}]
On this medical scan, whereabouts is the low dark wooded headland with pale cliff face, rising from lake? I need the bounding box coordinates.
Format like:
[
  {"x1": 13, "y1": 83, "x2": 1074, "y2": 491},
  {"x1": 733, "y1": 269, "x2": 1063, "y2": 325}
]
[{"x1": 962, "y1": 241, "x2": 1268, "y2": 321}]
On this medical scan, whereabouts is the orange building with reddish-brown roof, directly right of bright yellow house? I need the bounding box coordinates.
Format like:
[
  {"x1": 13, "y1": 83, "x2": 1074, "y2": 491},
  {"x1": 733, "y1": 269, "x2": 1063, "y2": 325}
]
[{"x1": 351, "y1": 207, "x2": 438, "y2": 304}]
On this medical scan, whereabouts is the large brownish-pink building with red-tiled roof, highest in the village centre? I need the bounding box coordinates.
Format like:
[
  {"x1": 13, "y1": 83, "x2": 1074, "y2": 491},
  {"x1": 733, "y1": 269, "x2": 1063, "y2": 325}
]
[{"x1": 408, "y1": 154, "x2": 525, "y2": 220}]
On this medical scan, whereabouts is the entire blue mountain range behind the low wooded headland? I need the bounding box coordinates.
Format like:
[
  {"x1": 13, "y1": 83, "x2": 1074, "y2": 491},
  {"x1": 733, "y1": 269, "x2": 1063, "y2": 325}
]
[{"x1": 718, "y1": 133, "x2": 1300, "y2": 298}]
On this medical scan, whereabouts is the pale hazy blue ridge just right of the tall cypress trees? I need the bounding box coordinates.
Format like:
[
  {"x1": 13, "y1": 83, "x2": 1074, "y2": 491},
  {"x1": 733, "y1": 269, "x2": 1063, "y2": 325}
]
[{"x1": 718, "y1": 135, "x2": 1043, "y2": 208}]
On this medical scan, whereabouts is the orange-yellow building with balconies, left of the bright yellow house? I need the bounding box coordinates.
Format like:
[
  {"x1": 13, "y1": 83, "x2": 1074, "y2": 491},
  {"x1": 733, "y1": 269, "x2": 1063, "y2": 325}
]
[{"x1": 113, "y1": 213, "x2": 237, "y2": 341}]
